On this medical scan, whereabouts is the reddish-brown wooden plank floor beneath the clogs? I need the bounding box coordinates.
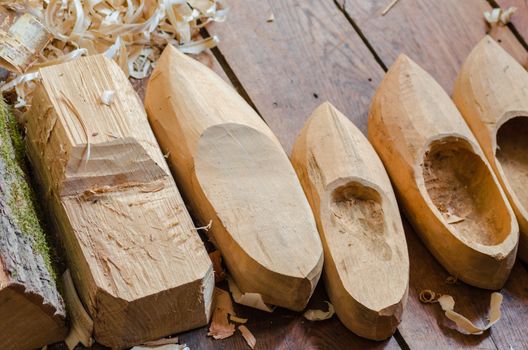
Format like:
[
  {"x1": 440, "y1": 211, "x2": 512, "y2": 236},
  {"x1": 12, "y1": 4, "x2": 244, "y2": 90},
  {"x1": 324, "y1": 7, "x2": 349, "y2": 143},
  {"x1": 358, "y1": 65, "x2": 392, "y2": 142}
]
[{"x1": 51, "y1": 0, "x2": 528, "y2": 350}]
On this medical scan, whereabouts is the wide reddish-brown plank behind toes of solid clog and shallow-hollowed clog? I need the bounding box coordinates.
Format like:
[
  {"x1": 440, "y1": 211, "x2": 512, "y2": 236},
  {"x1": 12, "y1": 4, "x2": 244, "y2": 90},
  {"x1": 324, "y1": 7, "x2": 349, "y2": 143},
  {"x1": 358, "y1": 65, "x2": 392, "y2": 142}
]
[{"x1": 208, "y1": 0, "x2": 383, "y2": 153}]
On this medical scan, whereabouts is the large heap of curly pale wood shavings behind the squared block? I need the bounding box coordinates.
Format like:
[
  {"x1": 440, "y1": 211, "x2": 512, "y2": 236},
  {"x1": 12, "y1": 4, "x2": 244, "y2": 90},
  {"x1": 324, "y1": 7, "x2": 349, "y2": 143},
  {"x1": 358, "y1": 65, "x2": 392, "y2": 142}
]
[{"x1": 0, "y1": 0, "x2": 228, "y2": 108}]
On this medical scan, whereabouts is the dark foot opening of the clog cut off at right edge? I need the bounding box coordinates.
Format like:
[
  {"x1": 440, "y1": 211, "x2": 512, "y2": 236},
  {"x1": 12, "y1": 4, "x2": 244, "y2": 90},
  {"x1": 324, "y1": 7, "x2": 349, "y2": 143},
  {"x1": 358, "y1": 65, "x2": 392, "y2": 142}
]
[{"x1": 496, "y1": 117, "x2": 528, "y2": 208}]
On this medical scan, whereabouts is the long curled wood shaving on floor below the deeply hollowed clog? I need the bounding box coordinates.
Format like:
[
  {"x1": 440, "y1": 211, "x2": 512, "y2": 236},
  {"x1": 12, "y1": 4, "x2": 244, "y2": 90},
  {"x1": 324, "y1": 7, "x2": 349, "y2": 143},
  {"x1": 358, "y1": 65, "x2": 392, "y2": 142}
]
[{"x1": 420, "y1": 289, "x2": 503, "y2": 335}]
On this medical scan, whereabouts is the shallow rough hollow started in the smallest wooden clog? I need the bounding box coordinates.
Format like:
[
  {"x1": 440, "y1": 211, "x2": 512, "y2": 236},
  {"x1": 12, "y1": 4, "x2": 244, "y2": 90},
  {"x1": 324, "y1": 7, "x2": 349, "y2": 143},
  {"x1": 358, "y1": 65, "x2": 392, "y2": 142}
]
[{"x1": 330, "y1": 182, "x2": 392, "y2": 260}]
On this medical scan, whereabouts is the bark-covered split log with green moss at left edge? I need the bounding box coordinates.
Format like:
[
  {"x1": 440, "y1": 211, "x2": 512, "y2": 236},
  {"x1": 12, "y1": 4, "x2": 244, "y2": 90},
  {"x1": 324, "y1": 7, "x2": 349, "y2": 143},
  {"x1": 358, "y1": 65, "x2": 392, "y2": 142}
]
[{"x1": 0, "y1": 99, "x2": 68, "y2": 350}]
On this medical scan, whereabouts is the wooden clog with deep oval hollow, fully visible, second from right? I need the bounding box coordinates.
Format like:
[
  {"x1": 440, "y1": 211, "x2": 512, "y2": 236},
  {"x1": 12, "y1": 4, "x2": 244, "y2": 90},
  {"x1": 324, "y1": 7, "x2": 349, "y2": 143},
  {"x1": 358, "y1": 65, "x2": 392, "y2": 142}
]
[{"x1": 368, "y1": 55, "x2": 519, "y2": 289}]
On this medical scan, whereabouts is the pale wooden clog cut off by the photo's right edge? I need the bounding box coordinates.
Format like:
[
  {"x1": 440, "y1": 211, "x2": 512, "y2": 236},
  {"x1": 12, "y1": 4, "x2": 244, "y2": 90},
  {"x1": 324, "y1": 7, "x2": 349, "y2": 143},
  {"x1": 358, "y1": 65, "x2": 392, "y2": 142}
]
[{"x1": 453, "y1": 36, "x2": 528, "y2": 262}]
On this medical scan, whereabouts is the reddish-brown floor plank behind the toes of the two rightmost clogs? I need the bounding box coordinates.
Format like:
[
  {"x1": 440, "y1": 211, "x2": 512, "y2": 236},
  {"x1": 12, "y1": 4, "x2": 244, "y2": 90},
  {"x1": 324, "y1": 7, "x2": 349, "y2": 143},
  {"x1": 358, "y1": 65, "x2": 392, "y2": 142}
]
[{"x1": 338, "y1": 0, "x2": 528, "y2": 93}]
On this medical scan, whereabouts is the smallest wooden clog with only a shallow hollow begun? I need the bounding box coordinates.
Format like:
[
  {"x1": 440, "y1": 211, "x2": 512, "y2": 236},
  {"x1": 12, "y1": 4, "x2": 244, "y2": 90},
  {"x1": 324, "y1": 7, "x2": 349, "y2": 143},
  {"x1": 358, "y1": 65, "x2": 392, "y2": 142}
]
[{"x1": 292, "y1": 103, "x2": 409, "y2": 340}]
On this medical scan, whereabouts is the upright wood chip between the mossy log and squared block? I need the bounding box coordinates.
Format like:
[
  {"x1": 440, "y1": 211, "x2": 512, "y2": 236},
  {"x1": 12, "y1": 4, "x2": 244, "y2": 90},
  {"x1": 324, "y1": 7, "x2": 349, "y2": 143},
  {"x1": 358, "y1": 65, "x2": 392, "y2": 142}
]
[{"x1": 62, "y1": 270, "x2": 94, "y2": 350}]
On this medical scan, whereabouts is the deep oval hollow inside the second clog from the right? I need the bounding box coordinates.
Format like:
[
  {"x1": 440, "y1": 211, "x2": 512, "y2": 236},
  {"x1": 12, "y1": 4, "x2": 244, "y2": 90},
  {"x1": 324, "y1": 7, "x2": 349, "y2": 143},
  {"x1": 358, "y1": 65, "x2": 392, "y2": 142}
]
[{"x1": 423, "y1": 138, "x2": 510, "y2": 245}]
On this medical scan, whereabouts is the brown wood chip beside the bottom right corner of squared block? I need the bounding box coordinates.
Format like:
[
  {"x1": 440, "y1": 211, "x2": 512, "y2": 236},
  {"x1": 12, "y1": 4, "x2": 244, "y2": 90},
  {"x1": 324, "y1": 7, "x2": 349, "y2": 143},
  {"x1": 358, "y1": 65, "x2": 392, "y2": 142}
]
[{"x1": 207, "y1": 287, "x2": 235, "y2": 339}]
